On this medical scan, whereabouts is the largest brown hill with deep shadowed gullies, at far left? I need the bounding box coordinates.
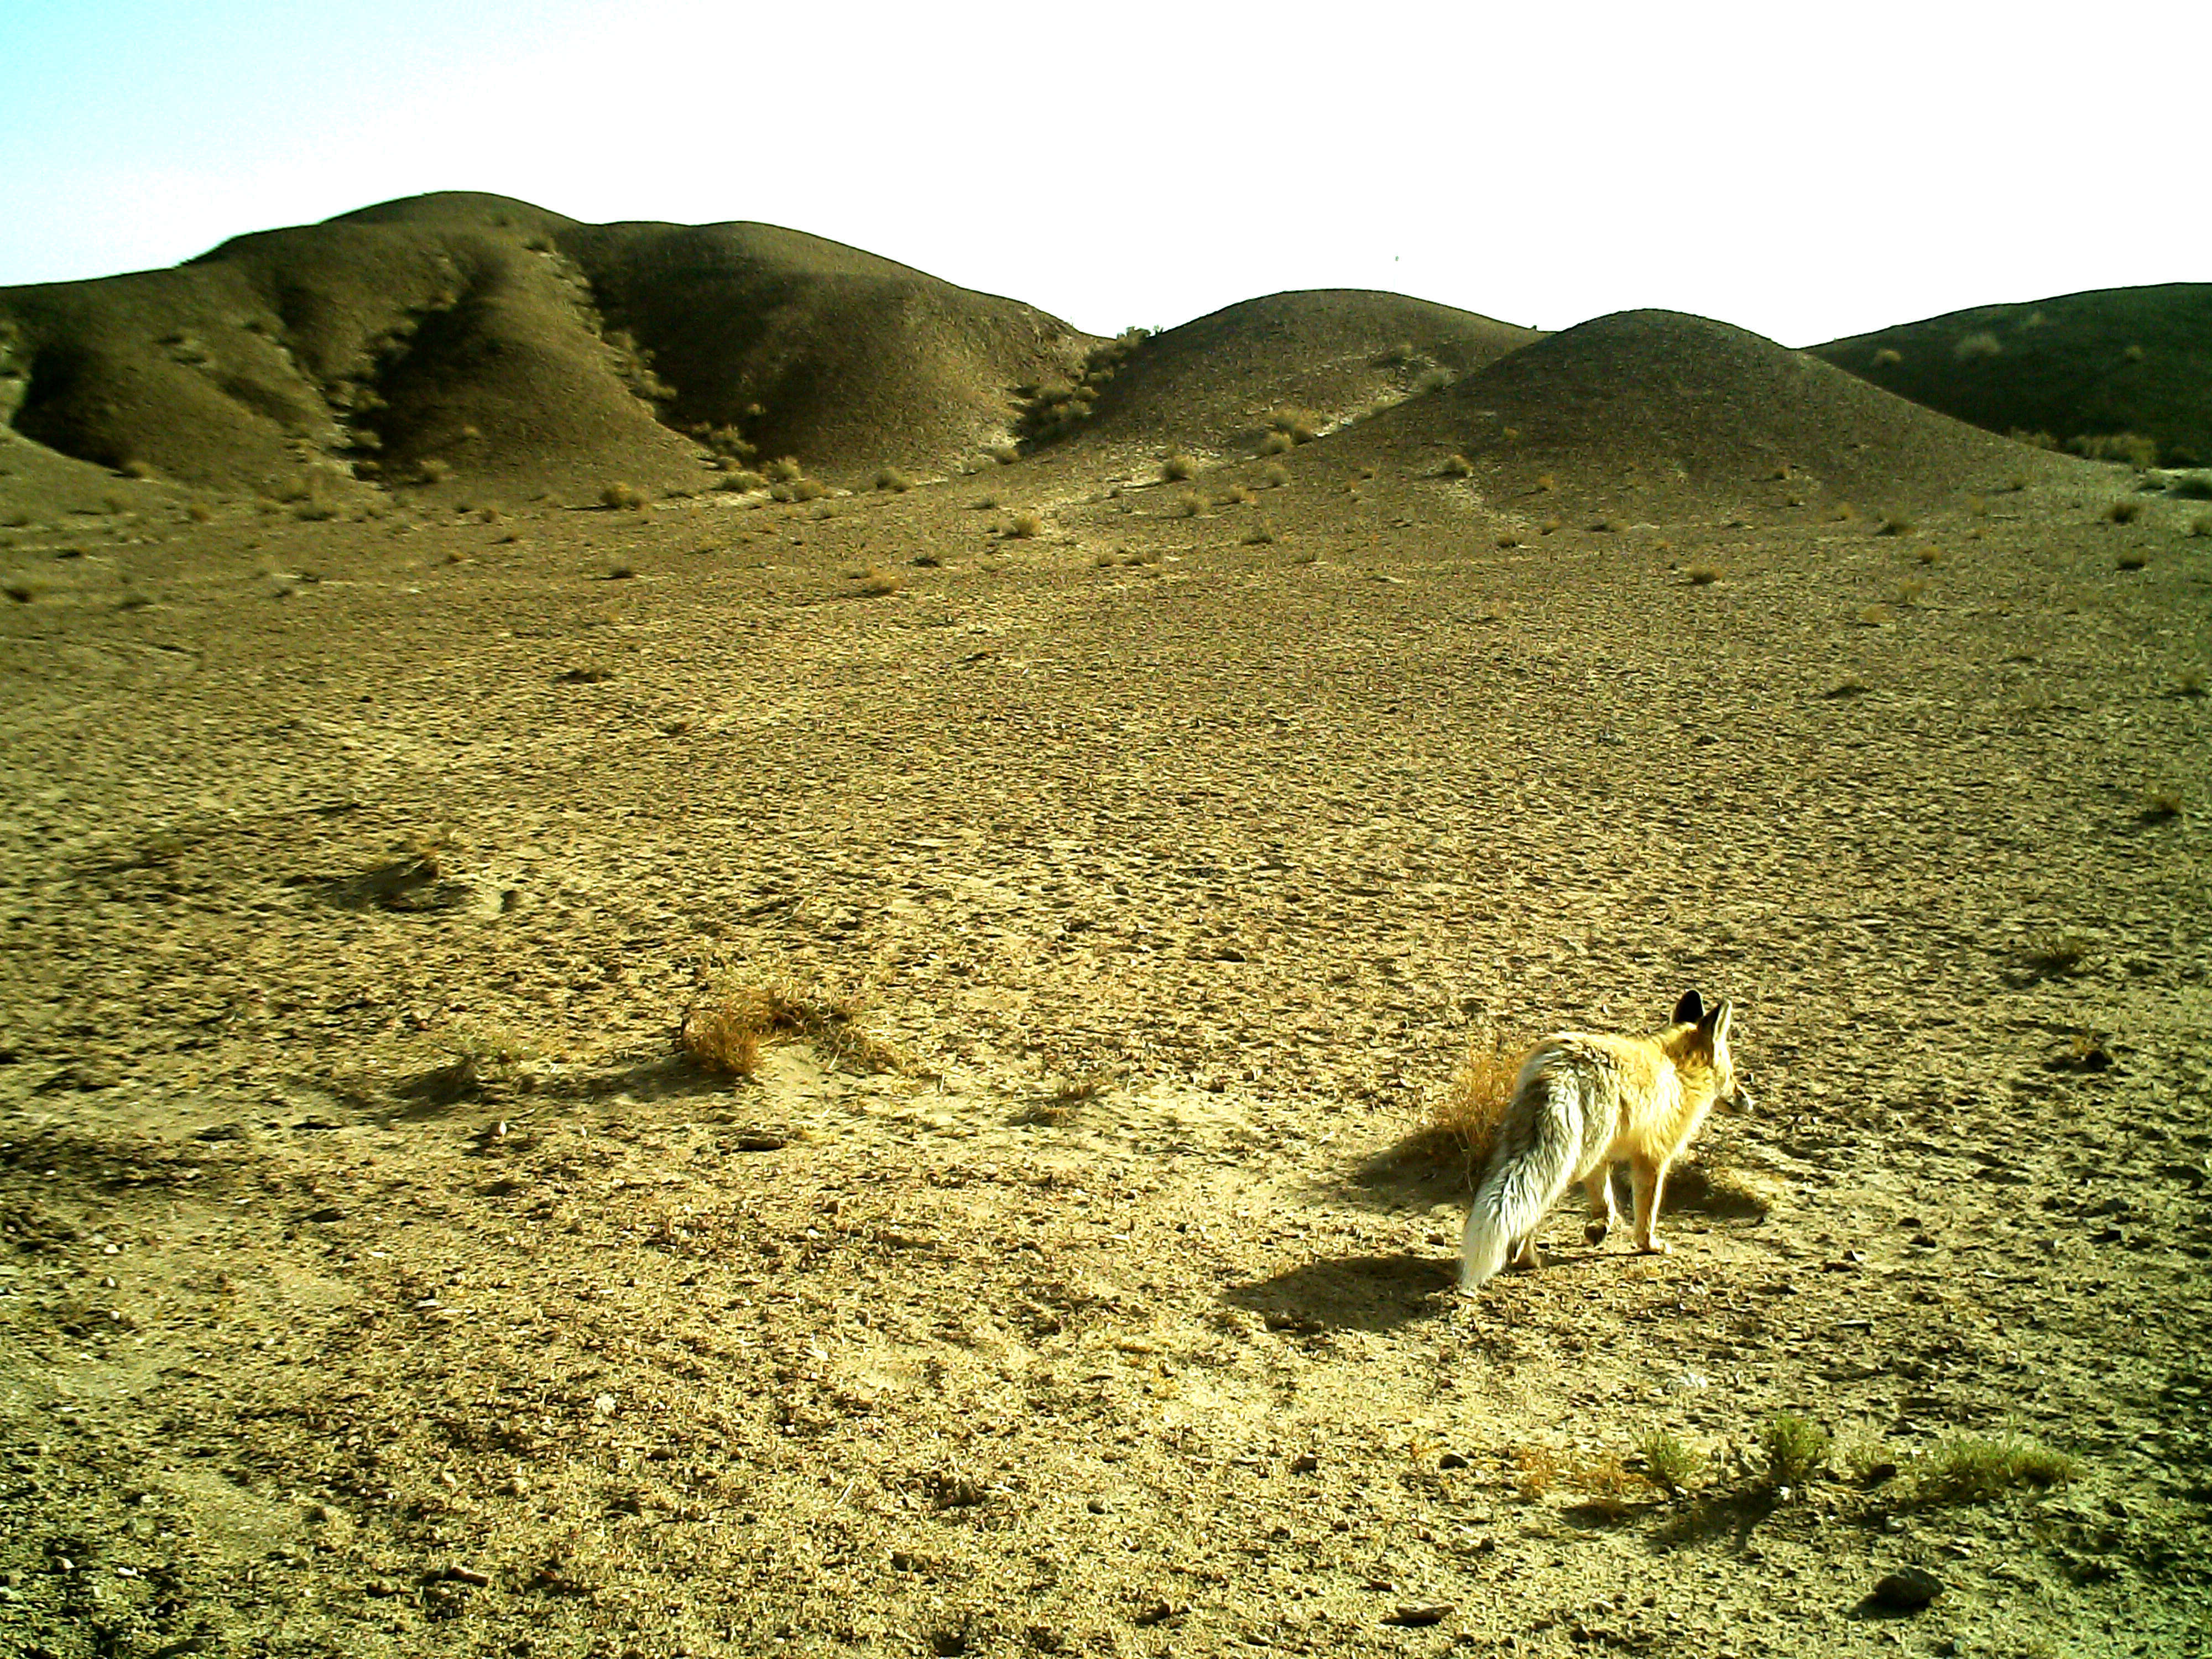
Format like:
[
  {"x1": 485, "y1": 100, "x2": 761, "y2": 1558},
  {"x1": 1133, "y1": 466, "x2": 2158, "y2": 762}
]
[{"x1": 0, "y1": 192, "x2": 1086, "y2": 489}]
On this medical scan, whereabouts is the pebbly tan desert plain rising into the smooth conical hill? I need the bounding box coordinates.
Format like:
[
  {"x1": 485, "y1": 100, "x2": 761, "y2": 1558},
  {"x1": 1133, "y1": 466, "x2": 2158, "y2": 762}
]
[{"x1": 0, "y1": 198, "x2": 2212, "y2": 1659}]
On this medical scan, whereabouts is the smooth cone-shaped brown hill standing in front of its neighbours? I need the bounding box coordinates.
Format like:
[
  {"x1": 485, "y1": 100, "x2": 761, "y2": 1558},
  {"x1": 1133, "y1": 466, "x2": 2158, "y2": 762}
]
[{"x1": 1329, "y1": 312, "x2": 2064, "y2": 500}]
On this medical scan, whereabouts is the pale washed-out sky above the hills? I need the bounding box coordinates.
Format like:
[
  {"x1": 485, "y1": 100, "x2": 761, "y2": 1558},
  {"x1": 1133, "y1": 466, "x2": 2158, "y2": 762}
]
[{"x1": 0, "y1": 0, "x2": 2212, "y2": 345}]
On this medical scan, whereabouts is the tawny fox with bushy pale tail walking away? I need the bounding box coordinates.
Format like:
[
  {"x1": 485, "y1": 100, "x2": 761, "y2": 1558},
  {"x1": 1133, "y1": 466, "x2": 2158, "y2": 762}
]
[{"x1": 1460, "y1": 991, "x2": 1752, "y2": 1296}]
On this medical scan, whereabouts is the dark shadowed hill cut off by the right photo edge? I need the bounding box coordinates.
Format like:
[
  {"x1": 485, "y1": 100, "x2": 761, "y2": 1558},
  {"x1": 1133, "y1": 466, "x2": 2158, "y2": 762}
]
[{"x1": 1812, "y1": 283, "x2": 2212, "y2": 467}]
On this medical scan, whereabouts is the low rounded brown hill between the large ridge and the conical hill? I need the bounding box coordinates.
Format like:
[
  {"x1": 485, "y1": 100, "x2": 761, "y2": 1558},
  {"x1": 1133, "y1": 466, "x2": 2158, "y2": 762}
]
[{"x1": 1031, "y1": 288, "x2": 1544, "y2": 462}]
